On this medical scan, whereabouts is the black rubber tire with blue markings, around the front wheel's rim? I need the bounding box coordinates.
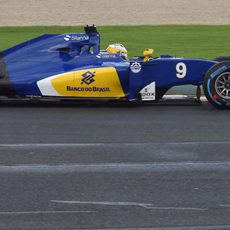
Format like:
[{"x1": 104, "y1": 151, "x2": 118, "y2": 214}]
[{"x1": 203, "y1": 61, "x2": 230, "y2": 109}]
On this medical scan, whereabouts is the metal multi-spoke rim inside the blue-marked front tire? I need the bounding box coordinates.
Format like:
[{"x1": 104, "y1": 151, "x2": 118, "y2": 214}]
[{"x1": 215, "y1": 72, "x2": 230, "y2": 100}]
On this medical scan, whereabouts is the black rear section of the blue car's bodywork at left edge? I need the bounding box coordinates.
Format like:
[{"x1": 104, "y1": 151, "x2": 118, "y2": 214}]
[{"x1": 0, "y1": 53, "x2": 16, "y2": 96}]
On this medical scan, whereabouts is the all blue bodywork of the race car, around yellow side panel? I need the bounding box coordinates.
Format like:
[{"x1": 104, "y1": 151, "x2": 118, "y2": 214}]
[{"x1": 0, "y1": 27, "x2": 217, "y2": 100}]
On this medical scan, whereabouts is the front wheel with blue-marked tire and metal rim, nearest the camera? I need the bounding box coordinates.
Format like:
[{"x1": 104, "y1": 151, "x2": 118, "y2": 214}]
[{"x1": 203, "y1": 61, "x2": 230, "y2": 109}]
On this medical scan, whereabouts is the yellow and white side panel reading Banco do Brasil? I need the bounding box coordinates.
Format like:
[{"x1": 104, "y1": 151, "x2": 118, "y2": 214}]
[{"x1": 37, "y1": 67, "x2": 125, "y2": 98}]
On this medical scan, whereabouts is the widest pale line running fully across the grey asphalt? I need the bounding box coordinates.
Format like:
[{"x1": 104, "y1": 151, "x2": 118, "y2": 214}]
[{"x1": 0, "y1": 161, "x2": 230, "y2": 174}]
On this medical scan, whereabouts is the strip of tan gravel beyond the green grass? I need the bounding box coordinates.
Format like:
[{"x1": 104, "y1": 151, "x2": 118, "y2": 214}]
[{"x1": 0, "y1": 0, "x2": 230, "y2": 26}]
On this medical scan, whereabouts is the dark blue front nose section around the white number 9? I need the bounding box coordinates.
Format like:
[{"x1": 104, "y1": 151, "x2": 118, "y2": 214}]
[{"x1": 129, "y1": 56, "x2": 217, "y2": 98}]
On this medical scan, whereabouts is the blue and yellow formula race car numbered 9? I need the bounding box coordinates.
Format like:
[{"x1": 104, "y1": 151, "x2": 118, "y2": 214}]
[{"x1": 0, "y1": 26, "x2": 230, "y2": 108}]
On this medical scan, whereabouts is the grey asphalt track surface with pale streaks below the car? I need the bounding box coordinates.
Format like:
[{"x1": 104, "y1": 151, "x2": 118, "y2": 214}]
[{"x1": 0, "y1": 99, "x2": 230, "y2": 230}]
